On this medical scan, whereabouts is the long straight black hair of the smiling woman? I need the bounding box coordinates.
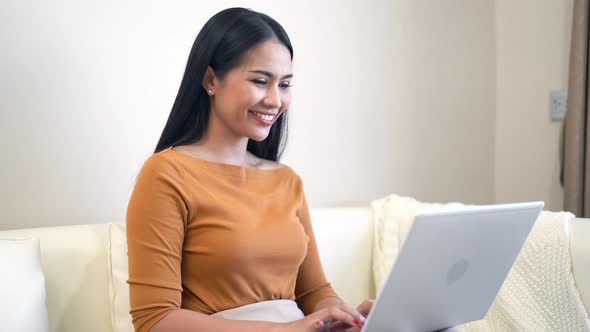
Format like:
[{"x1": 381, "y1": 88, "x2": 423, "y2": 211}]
[{"x1": 155, "y1": 8, "x2": 293, "y2": 161}]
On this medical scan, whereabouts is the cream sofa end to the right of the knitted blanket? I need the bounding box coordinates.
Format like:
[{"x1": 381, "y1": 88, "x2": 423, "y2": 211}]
[{"x1": 570, "y1": 218, "x2": 590, "y2": 311}]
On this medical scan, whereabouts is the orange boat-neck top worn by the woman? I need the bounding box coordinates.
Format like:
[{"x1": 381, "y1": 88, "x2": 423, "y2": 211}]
[{"x1": 127, "y1": 148, "x2": 337, "y2": 332}]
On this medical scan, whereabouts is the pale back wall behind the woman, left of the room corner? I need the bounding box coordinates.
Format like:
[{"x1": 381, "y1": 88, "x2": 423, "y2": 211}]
[{"x1": 0, "y1": 0, "x2": 496, "y2": 229}]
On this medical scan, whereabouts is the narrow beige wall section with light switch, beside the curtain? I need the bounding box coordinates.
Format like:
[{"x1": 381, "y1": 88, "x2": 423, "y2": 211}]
[{"x1": 495, "y1": 0, "x2": 573, "y2": 211}]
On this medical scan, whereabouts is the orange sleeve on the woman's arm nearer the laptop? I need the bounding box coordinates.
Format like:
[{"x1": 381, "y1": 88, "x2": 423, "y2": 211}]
[{"x1": 295, "y1": 182, "x2": 338, "y2": 315}]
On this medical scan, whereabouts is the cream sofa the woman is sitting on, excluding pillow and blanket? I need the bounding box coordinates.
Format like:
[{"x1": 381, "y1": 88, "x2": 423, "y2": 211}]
[{"x1": 0, "y1": 208, "x2": 590, "y2": 332}]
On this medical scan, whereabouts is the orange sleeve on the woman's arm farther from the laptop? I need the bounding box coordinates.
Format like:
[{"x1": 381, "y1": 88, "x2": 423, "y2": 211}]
[{"x1": 127, "y1": 155, "x2": 188, "y2": 332}]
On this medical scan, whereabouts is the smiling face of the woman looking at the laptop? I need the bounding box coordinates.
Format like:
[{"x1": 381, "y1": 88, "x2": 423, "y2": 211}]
[{"x1": 204, "y1": 40, "x2": 292, "y2": 141}]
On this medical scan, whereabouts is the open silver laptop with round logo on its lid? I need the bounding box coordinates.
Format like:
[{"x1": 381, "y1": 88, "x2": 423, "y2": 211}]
[{"x1": 362, "y1": 202, "x2": 544, "y2": 332}]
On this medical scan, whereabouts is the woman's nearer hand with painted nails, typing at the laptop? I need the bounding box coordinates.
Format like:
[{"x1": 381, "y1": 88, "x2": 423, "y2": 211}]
[{"x1": 277, "y1": 302, "x2": 370, "y2": 332}]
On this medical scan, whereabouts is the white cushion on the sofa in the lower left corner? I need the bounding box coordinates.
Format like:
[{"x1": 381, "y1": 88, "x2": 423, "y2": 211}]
[{"x1": 0, "y1": 238, "x2": 49, "y2": 332}]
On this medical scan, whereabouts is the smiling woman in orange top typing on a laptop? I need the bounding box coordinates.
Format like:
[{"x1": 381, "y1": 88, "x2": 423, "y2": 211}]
[{"x1": 127, "y1": 8, "x2": 373, "y2": 332}]
